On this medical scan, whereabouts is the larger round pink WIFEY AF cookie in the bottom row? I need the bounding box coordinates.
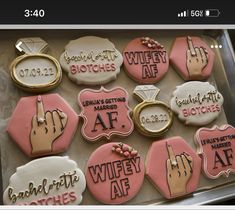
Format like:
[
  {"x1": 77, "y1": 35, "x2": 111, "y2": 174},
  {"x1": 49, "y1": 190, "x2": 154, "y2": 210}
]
[{"x1": 85, "y1": 142, "x2": 145, "y2": 204}]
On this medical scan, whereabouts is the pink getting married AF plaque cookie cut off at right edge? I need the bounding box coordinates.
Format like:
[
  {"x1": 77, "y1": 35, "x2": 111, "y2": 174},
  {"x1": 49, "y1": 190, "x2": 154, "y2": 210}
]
[{"x1": 194, "y1": 124, "x2": 235, "y2": 179}]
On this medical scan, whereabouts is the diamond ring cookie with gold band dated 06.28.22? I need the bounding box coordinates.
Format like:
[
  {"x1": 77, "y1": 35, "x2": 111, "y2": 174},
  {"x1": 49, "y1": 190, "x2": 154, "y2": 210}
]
[{"x1": 133, "y1": 85, "x2": 173, "y2": 137}]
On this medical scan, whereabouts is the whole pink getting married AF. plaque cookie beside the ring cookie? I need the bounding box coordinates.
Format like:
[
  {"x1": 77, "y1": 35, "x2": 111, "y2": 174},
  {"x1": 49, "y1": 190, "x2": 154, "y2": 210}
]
[{"x1": 78, "y1": 87, "x2": 134, "y2": 142}]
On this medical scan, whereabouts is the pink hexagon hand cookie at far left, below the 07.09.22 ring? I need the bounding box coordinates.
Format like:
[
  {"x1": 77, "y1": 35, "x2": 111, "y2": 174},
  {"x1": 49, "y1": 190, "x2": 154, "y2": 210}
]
[{"x1": 7, "y1": 94, "x2": 78, "y2": 157}]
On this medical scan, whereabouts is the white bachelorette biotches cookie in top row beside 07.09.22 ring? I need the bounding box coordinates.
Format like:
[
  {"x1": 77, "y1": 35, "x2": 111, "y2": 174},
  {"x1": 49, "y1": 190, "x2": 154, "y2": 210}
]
[{"x1": 60, "y1": 36, "x2": 123, "y2": 85}]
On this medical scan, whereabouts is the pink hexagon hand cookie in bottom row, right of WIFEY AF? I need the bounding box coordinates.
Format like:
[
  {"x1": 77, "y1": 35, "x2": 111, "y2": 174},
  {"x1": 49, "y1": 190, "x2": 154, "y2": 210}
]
[{"x1": 146, "y1": 136, "x2": 201, "y2": 199}]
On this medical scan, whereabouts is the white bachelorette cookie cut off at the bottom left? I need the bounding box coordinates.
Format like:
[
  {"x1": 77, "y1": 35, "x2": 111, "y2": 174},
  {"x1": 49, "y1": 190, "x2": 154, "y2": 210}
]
[{"x1": 3, "y1": 156, "x2": 86, "y2": 205}]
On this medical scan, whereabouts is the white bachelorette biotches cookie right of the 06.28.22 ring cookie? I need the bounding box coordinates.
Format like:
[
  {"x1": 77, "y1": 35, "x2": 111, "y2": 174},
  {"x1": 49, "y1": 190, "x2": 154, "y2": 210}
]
[{"x1": 171, "y1": 81, "x2": 224, "y2": 125}]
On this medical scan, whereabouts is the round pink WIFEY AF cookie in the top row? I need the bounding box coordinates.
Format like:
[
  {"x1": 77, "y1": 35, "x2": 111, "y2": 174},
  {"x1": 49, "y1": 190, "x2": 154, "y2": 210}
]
[{"x1": 123, "y1": 37, "x2": 169, "y2": 84}]
